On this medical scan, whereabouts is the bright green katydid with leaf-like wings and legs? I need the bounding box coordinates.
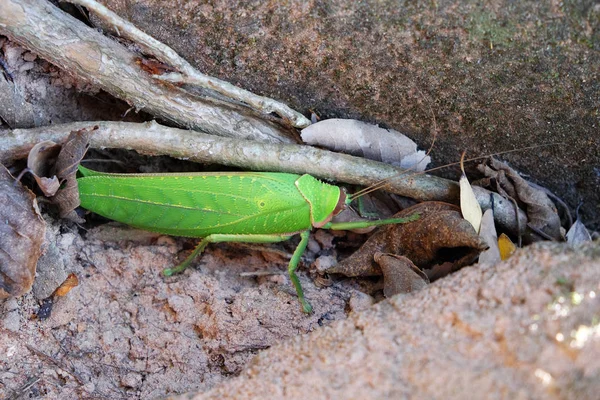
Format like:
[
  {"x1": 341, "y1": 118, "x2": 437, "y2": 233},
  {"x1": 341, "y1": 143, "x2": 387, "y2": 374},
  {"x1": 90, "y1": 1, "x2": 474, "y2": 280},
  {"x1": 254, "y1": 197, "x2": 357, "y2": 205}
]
[{"x1": 77, "y1": 166, "x2": 419, "y2": 313}]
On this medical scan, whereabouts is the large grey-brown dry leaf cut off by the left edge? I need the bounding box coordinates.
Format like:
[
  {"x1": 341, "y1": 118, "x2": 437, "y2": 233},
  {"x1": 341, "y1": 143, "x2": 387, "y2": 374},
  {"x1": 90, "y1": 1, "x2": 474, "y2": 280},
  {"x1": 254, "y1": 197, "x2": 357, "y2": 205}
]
[{"x1": 0, "y1": 164, "x2": 46, "y2": 298}]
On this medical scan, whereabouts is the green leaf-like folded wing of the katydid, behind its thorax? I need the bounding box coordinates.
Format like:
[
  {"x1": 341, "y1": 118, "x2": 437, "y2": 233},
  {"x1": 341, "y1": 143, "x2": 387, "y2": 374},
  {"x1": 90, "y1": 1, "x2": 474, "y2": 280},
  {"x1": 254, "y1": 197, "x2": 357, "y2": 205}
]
[{"x1": 78, "y1": 173, "x2": 318, "y2": 237}]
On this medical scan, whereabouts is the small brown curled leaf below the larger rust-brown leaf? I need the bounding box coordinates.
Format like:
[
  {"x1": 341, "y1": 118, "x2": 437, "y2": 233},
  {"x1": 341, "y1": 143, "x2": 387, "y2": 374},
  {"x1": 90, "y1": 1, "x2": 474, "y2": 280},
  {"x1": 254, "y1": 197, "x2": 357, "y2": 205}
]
[{"x1": 373, "y1": 253, "x2": 429, "y2": 297}]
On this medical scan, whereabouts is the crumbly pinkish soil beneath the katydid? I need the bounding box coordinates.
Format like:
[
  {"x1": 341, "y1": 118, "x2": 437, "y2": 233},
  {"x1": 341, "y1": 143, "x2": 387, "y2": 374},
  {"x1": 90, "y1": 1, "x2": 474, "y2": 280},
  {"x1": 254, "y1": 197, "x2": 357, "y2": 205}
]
[{"x1": 0, "y1": 216, "x2": 353, "y2": 399}]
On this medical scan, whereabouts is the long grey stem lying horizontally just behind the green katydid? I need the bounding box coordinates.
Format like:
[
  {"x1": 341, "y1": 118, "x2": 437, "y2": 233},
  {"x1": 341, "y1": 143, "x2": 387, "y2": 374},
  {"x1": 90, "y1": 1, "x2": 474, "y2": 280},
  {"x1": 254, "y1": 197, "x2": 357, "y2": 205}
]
[{"x1": 0, "y1": 122, "x2": 527, "y2": 234}]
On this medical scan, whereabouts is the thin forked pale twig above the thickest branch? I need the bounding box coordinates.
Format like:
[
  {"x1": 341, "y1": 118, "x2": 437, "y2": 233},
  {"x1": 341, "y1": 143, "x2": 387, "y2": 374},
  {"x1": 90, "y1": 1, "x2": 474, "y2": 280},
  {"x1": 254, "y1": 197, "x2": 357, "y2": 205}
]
[{"x1": 69, "y1": 0, "x2": 310, "y2": 128}]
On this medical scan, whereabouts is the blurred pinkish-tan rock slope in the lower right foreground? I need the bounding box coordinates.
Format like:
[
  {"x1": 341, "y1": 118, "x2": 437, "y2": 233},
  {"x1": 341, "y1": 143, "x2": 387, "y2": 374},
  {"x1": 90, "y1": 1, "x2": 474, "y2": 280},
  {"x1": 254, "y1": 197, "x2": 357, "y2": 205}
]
[{"x1": 172, "y1": 242, "x2": 600, "y2": 400}]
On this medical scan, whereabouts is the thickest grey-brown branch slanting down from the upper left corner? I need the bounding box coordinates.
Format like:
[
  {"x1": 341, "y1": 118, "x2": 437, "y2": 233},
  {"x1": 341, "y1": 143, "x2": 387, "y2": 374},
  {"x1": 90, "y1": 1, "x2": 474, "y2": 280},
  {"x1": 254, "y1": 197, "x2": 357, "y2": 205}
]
[{"x1": 0, "y1": 0, "x2": 295, "y2": 143}]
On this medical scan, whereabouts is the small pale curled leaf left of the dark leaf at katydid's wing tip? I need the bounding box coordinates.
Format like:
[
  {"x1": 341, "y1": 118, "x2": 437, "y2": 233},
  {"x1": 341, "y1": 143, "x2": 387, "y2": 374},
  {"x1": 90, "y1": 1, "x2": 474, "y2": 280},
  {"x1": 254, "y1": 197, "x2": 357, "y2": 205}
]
[{"x1": 27, "y1": 140, "x2": 61, "y2": 197}]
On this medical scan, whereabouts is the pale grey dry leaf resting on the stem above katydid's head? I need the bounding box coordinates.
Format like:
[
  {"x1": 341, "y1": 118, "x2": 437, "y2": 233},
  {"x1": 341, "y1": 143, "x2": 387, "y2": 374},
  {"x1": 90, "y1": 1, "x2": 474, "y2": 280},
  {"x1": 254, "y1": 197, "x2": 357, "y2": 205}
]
[{"x1": 301, "y1": 118, "x2": 431, "y2": 171}]
